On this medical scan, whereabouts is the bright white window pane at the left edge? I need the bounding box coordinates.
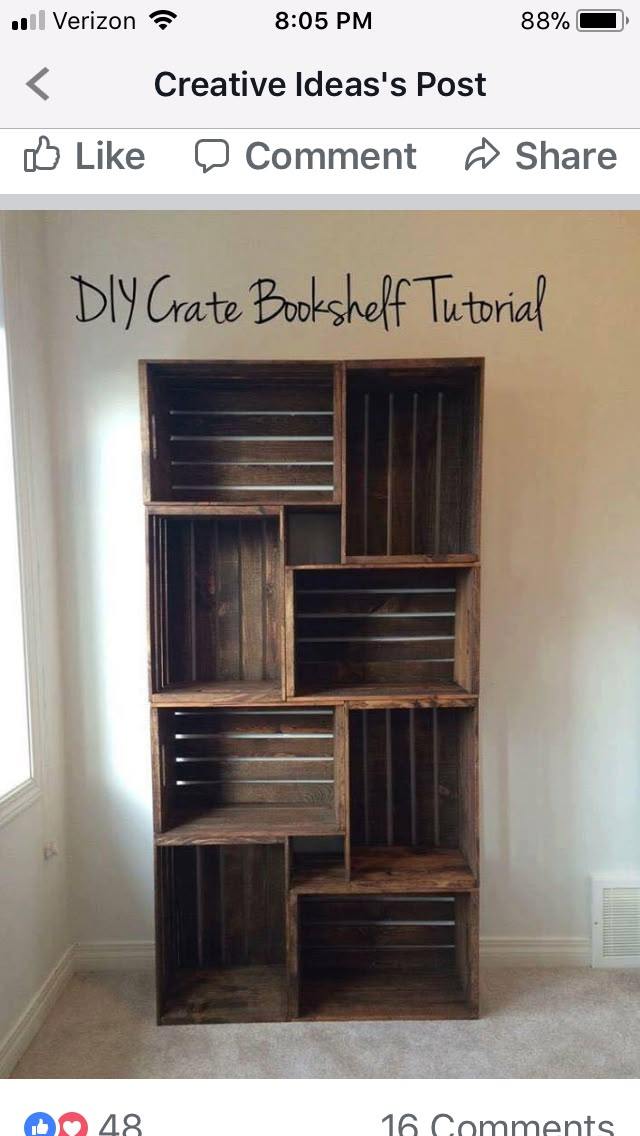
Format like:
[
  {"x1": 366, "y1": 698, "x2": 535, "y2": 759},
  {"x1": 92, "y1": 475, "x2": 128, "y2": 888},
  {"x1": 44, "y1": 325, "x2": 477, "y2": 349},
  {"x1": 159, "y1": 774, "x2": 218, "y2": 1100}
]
[{"x1": 0, "y1": 260, "x2": 33, "y2": 819}]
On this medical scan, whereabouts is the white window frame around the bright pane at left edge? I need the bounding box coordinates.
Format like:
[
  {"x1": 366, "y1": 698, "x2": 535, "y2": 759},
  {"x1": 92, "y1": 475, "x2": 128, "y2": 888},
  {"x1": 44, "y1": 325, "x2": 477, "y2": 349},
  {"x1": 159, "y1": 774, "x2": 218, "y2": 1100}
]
[{"x1": 0, "y1": 219, "x2": 44, "y2": 828}]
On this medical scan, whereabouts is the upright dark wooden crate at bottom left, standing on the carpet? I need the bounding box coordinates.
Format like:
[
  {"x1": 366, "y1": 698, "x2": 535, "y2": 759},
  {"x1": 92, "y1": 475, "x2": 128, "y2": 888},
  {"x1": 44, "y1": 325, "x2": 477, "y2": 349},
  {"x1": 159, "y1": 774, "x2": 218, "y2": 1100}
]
[{"x1": 156, "y1": 844, "x2": 286, "y2": 1024}]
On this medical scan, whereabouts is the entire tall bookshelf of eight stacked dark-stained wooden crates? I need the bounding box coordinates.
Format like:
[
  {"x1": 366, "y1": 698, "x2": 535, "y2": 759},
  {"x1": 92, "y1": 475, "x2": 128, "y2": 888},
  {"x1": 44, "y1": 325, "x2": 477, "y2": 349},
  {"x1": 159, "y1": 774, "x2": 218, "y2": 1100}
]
[{"x1": 141, "y1": 359, "x2": 483, "y2": 1022}]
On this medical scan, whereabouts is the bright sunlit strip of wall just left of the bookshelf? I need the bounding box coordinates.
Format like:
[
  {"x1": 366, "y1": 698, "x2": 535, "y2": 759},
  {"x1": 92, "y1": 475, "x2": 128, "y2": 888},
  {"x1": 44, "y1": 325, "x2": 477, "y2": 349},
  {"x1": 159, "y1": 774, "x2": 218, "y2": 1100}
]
[{"x1": 59, "y1": 386, "x2": 152, "y2": 939}]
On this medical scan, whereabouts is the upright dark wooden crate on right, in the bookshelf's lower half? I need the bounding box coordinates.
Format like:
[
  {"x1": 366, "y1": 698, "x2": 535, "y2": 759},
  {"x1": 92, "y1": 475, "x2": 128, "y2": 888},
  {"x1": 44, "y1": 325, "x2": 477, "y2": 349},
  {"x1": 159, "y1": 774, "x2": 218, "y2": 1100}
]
[{"x1": 349, "y1": 707, "x2": 477, "y2": 887}]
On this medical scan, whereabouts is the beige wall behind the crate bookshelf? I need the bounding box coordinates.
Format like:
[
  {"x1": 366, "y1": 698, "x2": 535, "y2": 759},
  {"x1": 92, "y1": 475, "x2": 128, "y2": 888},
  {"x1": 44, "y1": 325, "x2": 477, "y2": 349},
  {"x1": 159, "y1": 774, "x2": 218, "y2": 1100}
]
[{"x1": 25, "y1": 212, "x2": 640, "y2": 939}]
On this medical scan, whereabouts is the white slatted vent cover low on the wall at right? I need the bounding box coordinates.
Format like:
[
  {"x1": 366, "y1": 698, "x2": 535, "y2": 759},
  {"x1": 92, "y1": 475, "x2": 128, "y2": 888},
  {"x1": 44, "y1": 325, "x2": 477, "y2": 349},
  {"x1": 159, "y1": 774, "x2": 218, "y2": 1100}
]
[{"x1": 591, "y1": 875, "x2": 640, "y2": 967}]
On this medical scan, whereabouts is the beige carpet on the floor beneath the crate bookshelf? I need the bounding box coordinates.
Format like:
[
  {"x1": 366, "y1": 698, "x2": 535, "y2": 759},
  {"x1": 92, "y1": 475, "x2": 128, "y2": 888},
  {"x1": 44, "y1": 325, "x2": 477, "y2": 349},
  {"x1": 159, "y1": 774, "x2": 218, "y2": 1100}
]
[{"x1": 14, "y1": 969, "x2": 640, "y2": 1078}]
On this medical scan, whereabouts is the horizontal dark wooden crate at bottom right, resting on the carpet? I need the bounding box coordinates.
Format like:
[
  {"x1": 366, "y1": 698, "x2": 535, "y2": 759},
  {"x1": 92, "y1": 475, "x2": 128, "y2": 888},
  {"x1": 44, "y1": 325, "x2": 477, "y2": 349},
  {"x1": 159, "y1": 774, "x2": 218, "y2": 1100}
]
[{"x1": 298, "y1": 893, "x2": 477, "y2": 1020}]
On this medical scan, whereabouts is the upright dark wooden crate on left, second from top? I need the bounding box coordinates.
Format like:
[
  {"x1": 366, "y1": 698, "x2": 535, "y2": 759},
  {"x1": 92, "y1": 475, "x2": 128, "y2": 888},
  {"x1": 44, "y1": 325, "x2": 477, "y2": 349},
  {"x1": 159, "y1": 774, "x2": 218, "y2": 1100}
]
[{"x1": 149, "y1": 512, "x2": 282, "y2": 702}]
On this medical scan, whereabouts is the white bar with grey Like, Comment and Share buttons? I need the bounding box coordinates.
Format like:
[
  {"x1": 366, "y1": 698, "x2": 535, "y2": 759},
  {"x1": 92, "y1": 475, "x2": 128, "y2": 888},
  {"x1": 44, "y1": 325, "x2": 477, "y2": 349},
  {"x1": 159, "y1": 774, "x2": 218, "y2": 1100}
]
[{"x1": 0, "y1": 125, "x2": 640, "y2": 197}]
